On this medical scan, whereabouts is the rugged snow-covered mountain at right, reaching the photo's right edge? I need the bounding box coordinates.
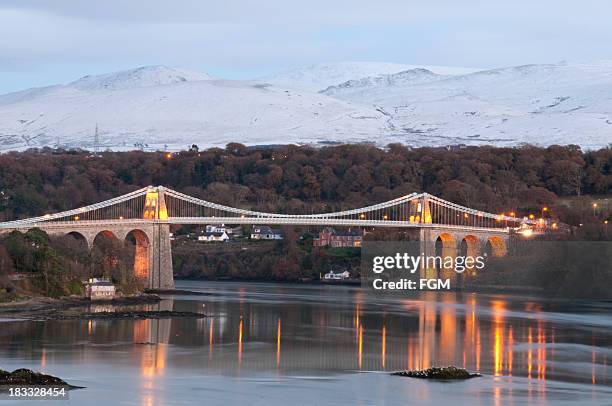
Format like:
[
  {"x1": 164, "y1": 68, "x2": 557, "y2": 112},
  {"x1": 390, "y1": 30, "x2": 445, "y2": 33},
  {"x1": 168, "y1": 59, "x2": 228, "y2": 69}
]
[{"x1": 322, "y1": 63, "x2": 612, "y2": 148}]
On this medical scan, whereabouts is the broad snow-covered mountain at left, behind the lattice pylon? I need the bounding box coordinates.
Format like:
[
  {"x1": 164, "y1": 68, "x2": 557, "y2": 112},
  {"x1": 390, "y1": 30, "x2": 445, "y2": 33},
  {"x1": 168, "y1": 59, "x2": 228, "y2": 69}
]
[{"x1": 0, "y1": 67, "x2": 387, "y2": 150}]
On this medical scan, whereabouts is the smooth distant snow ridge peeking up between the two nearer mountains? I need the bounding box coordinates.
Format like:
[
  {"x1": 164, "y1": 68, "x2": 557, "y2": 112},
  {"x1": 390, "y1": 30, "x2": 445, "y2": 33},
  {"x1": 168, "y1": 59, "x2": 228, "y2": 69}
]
[{"x1": 258, "y1": 62, "x2": 476, "y2": 92}]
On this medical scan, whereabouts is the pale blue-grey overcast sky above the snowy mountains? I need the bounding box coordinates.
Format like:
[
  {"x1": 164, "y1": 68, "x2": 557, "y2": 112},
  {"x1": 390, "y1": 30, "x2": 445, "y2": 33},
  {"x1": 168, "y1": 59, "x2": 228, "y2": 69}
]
[{"x1": 0, "y1": 0, "x2": 612, "y2": 93}]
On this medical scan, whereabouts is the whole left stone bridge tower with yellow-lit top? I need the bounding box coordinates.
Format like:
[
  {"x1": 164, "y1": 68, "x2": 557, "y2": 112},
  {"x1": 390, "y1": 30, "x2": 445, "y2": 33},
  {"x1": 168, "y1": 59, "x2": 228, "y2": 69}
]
[{"x1": 142, "y1": 186, "x2": 174, "y2": 289}]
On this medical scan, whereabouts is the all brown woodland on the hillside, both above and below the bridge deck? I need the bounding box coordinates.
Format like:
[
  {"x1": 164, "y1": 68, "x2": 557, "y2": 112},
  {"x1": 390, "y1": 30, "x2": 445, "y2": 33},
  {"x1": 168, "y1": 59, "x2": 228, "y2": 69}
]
[{"x1": 0, "y1": 143, "x2": 612, "y2": 295}]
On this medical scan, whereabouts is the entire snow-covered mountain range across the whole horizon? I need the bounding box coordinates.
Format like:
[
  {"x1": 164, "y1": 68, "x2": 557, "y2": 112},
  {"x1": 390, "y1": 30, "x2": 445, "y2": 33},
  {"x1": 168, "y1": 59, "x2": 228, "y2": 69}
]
[{"x1": 0, "y1": 62, "x2": 612, "y2": 150}]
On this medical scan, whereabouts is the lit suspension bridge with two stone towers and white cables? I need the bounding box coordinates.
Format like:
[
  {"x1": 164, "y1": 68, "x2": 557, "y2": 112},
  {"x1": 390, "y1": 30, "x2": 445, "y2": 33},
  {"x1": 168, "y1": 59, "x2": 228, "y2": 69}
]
[{"x1": 0, "y1": 186, "x2": 533, "y2": 289}]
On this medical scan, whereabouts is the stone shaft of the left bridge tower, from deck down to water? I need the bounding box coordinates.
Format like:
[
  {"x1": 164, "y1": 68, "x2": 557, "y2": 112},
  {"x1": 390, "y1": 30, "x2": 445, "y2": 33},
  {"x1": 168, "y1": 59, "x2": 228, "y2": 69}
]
[{"x1": 148, "y1": 223, "x2": 174, "y2": 289}]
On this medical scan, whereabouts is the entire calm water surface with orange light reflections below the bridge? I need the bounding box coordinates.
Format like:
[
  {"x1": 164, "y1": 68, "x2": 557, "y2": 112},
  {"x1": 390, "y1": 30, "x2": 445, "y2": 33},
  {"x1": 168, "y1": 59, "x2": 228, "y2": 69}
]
[{"x1": 0, "y1": 281, "x2": 612, "y2": 405}]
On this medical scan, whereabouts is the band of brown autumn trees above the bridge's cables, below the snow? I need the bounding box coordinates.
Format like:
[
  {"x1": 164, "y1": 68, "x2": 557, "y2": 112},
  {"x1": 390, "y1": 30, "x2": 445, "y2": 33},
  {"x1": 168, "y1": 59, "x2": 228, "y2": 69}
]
[{"x1": 0, "y1": 143, "x2": 612, "y2": 225}]
